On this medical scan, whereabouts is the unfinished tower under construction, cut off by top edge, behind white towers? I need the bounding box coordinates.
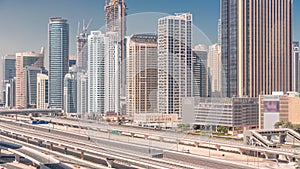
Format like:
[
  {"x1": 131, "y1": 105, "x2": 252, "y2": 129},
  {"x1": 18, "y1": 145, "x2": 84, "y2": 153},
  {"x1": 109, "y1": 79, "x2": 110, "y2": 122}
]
[{"x1": 104, "y1": 0, "x2": 126, "y2": 96}]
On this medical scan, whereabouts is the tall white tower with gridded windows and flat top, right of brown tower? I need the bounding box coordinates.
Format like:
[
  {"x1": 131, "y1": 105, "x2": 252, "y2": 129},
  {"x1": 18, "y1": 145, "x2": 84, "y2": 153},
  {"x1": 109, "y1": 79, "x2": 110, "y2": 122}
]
[{"x1": 158, "y1": 13, "x2": 193, "y2": 118}]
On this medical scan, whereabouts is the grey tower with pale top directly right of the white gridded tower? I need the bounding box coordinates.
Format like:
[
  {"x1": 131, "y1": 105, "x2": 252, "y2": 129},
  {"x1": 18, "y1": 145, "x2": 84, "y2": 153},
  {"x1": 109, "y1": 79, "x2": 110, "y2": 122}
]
[{"x1": 192, "y1": 45, "x2": 211, "y2": 97}]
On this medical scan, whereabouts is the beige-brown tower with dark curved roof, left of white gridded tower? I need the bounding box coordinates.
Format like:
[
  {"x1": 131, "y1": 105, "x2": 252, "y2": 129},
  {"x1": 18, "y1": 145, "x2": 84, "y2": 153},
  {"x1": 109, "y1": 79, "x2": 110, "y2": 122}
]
[{"x1": 126, "y1": 34, "x2": 157, "y2": 121}]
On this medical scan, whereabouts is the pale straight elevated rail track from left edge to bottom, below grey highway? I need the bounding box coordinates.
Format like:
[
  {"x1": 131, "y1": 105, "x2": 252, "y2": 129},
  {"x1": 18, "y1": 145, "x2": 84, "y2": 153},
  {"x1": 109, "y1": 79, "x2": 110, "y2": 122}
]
[{"x1": 0, "y1": 123, "x2": 199, "y2": 169}]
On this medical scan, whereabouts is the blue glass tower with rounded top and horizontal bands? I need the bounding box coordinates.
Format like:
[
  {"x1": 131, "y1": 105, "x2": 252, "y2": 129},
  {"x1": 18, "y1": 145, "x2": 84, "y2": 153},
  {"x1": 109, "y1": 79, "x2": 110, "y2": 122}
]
[{"x1": 48, "y1": 17, "x2": 69, "y2": 109}]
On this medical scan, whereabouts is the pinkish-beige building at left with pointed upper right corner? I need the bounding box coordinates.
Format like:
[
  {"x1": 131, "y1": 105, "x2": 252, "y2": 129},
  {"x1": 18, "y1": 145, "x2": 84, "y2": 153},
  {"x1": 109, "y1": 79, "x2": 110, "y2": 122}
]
[{"x1": 15, "y1": 48, "x2": 44, "y2": 108}]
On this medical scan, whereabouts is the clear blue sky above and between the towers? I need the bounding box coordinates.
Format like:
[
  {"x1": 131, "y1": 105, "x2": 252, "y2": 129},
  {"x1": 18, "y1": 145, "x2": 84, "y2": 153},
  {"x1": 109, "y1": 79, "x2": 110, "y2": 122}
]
[{"x1": 0, "y1": 0, "x2": 300, "y2": 55}]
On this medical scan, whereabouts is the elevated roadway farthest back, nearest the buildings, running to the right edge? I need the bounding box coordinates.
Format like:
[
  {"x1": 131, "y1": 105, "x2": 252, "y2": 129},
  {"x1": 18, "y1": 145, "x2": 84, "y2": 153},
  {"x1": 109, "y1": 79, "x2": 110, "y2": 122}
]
[{"x1": 17, "y1": 117, "x2": 300, "y2": 161}]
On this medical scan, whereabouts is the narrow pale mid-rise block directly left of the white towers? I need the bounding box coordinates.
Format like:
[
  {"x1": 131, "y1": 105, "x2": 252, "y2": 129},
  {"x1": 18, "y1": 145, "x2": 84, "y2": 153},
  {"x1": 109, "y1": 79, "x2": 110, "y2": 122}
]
[{"x1": 77, "y1": 72, "x2": 88, "y2": 118}]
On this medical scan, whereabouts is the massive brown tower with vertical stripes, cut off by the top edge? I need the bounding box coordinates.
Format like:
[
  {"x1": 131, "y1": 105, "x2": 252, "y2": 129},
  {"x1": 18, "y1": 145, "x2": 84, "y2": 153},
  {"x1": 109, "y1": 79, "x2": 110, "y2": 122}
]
[{"x1": 221, "y1": 0, "x2": 292, "y2": 97}]
